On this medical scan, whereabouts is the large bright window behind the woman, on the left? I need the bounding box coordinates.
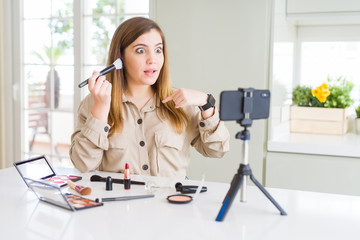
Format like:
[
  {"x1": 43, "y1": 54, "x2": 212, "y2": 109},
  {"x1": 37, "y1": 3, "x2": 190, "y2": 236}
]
[{"x1": 19, "y1": 0, "x2": 149, "y2": 166}]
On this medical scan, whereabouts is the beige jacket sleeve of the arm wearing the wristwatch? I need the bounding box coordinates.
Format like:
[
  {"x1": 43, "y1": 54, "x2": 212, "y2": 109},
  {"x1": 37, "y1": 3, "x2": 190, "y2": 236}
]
[{"x1": 190, "y1": 109, "x2": 230, "y2": 158}]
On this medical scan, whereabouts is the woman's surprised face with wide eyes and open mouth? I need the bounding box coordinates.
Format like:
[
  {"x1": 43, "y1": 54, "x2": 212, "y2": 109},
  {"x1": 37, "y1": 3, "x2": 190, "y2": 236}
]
[{"x1": 124, "y1": 29, "x2": 164, "y2": 85}]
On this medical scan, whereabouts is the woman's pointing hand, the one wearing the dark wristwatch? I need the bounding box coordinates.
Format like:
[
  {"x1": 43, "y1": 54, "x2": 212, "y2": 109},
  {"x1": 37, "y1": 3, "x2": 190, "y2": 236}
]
[{"x1": 162, "y1": 88, "x2": 214, "y2": 119}]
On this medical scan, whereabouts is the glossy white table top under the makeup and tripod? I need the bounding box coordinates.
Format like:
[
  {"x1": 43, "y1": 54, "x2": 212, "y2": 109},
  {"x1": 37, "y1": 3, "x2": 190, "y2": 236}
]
[{"x1": 0, "y1": 167, "x2": 360, "y2": 240}]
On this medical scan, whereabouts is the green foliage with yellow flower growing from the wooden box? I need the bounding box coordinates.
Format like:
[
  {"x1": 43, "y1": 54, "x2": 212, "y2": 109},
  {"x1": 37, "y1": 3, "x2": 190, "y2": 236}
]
[{"x1": 292, "y1": 77, "x2": 354, "y2": 108}]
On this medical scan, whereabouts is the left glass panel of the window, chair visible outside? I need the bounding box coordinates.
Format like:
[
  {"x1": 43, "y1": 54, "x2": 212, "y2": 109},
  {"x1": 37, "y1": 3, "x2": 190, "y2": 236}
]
[{"x1": 22, "y1": 0, "x2": 74, "y2": 165}]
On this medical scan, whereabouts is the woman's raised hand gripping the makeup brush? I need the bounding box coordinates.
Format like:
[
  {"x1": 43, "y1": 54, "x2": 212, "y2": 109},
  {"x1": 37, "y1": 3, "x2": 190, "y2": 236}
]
[{"x1": 88, "y1": 71, "x2": 112, "y2": 122}]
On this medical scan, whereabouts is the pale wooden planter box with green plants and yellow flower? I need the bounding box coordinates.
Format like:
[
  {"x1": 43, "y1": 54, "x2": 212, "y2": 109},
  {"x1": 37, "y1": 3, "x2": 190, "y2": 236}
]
[{"x1": 290, "y1": 77, "x2": 354, "y2": 135}]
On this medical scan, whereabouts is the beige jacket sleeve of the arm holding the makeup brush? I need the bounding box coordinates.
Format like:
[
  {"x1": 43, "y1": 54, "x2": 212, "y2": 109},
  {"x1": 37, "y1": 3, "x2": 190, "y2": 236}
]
[{"x1": 69, "y1": 95, "x2": 110, "y2": 172}]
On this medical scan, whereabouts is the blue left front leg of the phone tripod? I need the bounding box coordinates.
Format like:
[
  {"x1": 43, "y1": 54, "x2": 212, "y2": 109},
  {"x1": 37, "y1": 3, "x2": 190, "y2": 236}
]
[{"x1": 215, "y1": 173, "x2": 244, "y2": 222}]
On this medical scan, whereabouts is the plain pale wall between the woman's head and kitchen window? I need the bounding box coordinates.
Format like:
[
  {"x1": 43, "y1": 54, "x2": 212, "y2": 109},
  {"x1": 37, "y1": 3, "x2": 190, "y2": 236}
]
[{"x1": 152, "y1": 0, "x2": 272, "y2": 182}]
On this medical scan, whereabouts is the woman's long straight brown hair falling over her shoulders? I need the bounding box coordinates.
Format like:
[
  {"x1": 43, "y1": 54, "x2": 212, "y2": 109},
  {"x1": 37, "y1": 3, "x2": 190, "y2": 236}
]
[{"x1": 107, "y1": 17, "x2": 189, "y2": 136}]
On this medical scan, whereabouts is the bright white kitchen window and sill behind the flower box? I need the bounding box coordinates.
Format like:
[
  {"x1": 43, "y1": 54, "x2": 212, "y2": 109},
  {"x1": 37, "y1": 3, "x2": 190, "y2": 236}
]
[{"x1": 268, "y1": 0, "x2": 360, "y2": 157}]
